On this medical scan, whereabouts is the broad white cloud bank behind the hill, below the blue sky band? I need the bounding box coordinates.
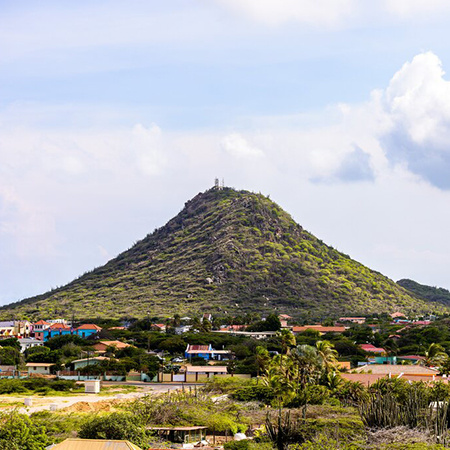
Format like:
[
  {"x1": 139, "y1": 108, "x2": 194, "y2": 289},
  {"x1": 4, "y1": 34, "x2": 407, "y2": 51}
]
[{"x1": 0, "y1": 52, "x2": 450, "y2": 302}]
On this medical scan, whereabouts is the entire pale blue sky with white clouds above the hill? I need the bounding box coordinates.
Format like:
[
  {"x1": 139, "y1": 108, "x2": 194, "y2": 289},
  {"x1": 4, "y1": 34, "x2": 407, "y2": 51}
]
[{"x1": 0, "y1": 0, "x2": 450, "y2": 304}]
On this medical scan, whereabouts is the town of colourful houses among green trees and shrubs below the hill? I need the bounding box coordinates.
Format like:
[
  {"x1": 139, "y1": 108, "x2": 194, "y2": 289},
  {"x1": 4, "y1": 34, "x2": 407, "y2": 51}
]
[{"x1": 0, "y1": 311, "x2": 450, "y2": 450}]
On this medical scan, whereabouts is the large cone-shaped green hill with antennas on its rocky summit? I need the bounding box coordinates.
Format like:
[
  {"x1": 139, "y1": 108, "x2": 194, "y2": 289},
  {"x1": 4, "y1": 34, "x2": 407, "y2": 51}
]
[{"x1": 0, "y1": 188, "x2": 442, "y2": 319}]
